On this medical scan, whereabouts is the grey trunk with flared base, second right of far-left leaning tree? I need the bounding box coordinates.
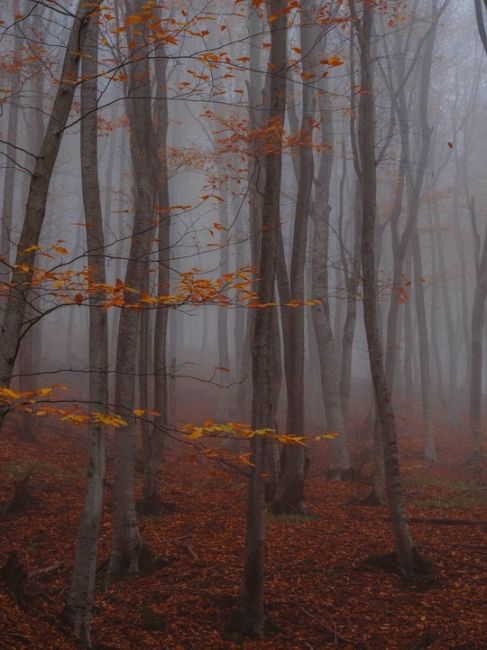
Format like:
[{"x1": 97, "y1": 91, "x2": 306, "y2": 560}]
[{"x1": 108, "y1": 10, "x2": 156, "y2": 577}]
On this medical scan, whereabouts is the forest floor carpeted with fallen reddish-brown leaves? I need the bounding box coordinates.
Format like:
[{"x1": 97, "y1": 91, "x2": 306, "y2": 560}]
[{"x1": 0, "y1": 408, "x2": 487, "y2": 650}]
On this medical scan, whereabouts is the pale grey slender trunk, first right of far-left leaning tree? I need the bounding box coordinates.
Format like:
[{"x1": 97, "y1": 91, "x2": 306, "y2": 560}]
[{"x1": 63, "y1": 16, "x2": 108, "y2": 648}]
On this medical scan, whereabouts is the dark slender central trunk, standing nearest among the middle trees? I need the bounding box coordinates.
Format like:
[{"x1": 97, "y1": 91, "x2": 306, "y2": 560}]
[{"x1": 241, "y1": 0, "x2": 287, "y2": 637}]
